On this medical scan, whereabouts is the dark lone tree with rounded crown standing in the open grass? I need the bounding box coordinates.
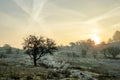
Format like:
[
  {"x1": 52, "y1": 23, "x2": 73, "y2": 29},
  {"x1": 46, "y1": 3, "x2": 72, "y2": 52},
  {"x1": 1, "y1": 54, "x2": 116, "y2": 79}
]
[{"x1": 23, "y1": 35, "x2": 57, "y2": 66}]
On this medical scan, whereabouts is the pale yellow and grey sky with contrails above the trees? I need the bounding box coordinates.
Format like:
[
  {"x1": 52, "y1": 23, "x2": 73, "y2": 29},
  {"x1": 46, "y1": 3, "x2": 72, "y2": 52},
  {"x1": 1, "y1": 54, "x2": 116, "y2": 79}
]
[{"x1": 0, "y1": 0, "x2": 120, "y2": 48}]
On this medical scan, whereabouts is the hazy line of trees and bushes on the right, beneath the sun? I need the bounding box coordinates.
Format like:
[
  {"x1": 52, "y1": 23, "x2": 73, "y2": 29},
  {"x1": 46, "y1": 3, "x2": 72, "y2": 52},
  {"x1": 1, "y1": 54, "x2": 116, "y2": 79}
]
[{"x1": 57, "y1": 31, "x2": 120, "y2": 59}]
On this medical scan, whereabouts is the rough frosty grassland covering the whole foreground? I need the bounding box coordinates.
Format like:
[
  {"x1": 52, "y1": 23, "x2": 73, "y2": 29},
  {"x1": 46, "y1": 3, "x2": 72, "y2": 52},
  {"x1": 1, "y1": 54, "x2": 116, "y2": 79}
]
[{"x1": 0, "y1": 57, "x2": 120, "y2": 80}]
